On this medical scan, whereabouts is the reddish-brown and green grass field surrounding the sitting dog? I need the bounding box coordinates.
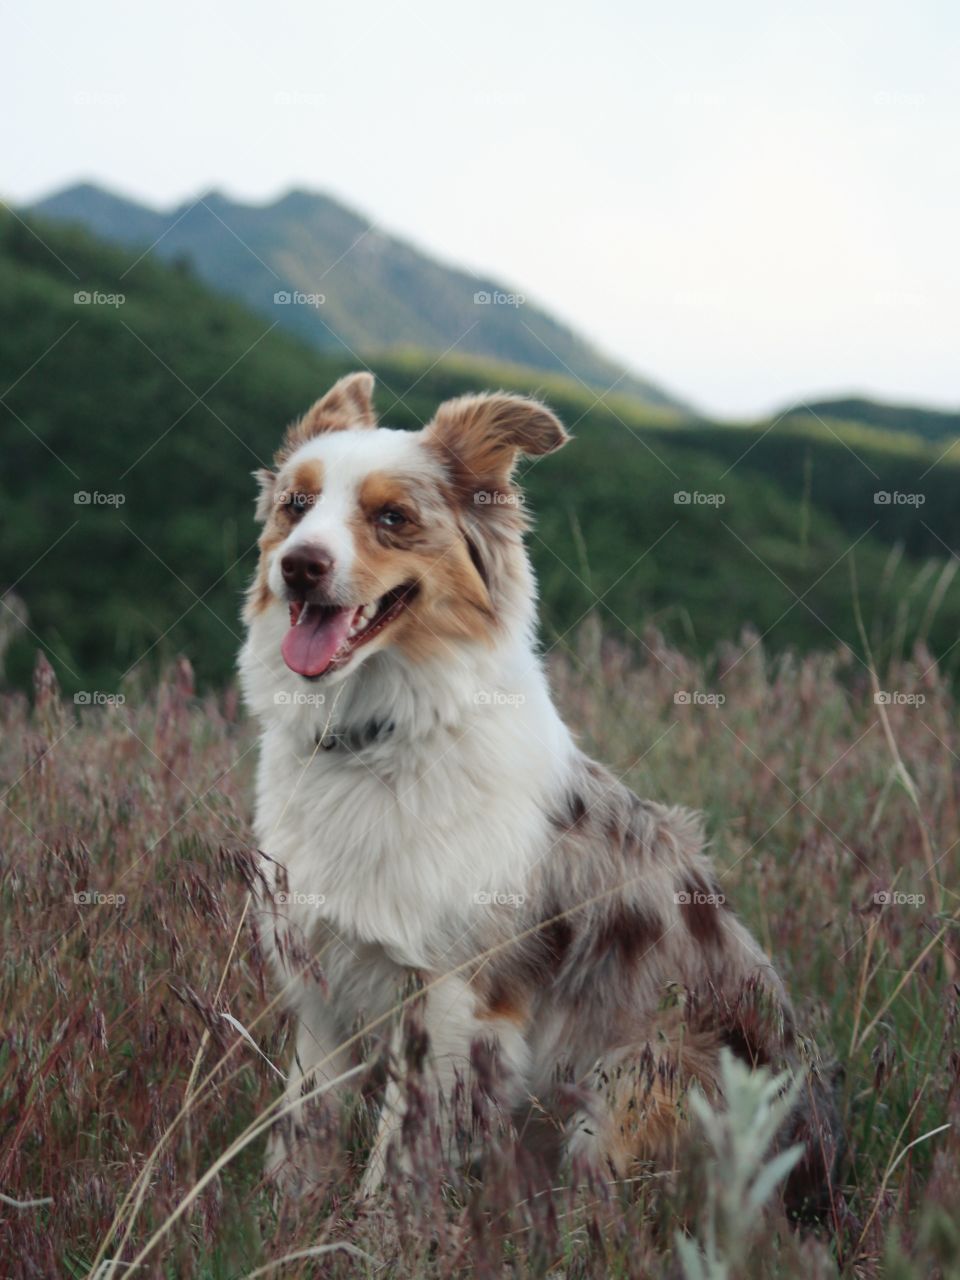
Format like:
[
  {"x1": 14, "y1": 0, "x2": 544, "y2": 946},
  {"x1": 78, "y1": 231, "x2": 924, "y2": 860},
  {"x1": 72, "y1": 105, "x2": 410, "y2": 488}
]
[{"x1": 0, "y1": 622, "x2": 960, "y2": 1280}]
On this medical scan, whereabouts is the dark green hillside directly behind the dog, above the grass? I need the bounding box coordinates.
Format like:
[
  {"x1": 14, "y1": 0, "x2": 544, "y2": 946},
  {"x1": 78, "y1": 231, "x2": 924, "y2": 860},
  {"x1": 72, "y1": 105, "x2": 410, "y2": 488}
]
[{"x1": 0, "y1": 218, "x2": 960, "y2": 690}]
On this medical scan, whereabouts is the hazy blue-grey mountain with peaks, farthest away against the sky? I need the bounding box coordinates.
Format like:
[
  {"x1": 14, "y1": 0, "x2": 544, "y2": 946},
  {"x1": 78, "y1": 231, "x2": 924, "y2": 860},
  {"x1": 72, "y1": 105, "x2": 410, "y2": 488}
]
[{"x1": 32, "y1": 183, "x2": 684, "y2": 408}]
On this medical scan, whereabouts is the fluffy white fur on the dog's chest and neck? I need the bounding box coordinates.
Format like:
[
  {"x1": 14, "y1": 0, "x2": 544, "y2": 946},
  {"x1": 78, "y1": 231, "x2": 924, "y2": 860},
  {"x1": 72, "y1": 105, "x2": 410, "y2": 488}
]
[{"x1": 242, "y1": 627, "x2": 572, "y2": 968}]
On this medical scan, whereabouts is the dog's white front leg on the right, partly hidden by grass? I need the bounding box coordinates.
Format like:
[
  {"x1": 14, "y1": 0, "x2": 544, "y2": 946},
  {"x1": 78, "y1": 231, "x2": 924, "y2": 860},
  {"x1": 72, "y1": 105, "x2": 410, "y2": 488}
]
[{"x1": 361, "y1": 977, "x2": 529, "y2": 1196}]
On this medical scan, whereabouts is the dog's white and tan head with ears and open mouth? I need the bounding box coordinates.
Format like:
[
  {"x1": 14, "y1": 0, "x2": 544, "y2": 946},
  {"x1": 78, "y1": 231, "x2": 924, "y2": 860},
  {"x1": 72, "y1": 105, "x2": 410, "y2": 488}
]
[{"x1": 247, "y1": 374, "x2": 567, "y2": 680}]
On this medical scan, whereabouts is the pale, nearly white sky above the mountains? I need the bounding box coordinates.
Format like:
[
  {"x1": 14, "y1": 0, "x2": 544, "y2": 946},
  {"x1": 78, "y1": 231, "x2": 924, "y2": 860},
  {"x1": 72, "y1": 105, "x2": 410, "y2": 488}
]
[{"x1": 0, "y1": 0, "x2": 960, "y2": 415}]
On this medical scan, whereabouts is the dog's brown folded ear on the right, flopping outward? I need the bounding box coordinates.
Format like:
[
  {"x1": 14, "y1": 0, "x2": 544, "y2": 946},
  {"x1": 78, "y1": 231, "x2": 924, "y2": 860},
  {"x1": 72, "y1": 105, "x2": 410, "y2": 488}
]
[{"x1": 424, "y1": 392, "x2": 570, "y2": 494}]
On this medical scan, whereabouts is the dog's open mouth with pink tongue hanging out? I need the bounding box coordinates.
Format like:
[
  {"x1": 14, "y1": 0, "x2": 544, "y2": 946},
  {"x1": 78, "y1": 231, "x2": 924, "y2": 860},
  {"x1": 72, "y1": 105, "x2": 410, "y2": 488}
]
[{"x1": 280, "y1": 582, "x2": 416, "y2": 680}]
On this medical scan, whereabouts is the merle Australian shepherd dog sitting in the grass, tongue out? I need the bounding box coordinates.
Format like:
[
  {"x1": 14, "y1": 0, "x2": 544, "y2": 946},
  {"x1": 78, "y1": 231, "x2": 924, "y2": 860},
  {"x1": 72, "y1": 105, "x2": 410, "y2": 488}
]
[{"x1": 239, "y1": 372, "x2": 837, "y2": 1206}]
